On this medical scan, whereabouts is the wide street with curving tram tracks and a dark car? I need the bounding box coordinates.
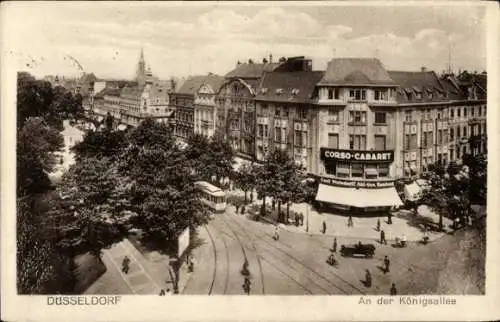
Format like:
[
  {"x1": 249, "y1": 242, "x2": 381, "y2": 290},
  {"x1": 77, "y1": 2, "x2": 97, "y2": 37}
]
[{"x1": 183, "y1": 203, "x2": 484, "y2": 295}]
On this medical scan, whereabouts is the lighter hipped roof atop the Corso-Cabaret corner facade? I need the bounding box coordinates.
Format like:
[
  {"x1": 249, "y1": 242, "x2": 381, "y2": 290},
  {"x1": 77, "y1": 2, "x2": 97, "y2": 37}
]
[{"x1": 319, "y1": 58, "x2": 394, "y2": 85}]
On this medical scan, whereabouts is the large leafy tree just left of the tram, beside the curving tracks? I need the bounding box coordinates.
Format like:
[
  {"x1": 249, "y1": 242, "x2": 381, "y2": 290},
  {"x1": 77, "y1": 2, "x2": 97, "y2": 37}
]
[{"x1": 119, "y1": 120, "x2": 209, "y2": 243}]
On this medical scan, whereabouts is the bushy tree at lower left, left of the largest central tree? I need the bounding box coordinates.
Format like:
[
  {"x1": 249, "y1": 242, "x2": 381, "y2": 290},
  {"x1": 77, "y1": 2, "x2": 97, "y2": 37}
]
[{"x1": 55, "y1": 158, "x2": 130, "y2": 259}]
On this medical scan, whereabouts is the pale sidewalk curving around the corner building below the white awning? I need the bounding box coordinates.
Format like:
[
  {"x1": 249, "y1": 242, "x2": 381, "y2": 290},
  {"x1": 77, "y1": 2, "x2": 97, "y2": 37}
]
[{"x1": 228, "y1": 191, "x2": 452, "y2": 242}]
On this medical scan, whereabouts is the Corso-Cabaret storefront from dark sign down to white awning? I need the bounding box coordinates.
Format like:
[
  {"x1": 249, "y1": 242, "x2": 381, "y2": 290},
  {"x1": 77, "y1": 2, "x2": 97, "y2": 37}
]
[{"x1": 316, "y1": 148, "x2": 403, "y2": 213}]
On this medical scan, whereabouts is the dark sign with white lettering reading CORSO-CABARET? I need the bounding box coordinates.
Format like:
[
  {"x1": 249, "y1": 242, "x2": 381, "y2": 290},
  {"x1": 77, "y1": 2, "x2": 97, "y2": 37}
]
[{"x1": 320, "y1": 148, "x2": 394, "y2": 162}]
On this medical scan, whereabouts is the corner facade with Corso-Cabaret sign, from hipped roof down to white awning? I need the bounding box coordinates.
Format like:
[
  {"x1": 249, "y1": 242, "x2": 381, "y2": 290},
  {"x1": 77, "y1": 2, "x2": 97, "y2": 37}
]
[{"x1": 313, "y1": 58, "x2": 401, "y2": 212}]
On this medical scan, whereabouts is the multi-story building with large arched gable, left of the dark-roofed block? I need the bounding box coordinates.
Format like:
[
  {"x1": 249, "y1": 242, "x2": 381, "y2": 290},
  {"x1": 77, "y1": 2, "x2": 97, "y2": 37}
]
[{"x1": 215, "y1": 56, "x2": 280, "y2": 159}]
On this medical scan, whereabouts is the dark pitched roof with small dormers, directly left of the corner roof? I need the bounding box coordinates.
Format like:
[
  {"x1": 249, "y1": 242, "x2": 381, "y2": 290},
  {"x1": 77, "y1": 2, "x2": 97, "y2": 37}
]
[{"x1": 256, "y1": 71, "x2": 324, "y2": 102}]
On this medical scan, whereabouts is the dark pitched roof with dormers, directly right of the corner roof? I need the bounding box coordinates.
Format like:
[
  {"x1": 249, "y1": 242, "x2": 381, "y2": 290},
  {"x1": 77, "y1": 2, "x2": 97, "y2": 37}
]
[{"x1": 388, "y1": 71, "x2": 451, "y2": 103}]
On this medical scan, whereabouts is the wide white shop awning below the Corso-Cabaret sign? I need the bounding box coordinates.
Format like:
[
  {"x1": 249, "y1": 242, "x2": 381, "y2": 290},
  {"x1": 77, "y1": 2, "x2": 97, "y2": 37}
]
[{"x1": 316, "y1": 184, "x2": 403, "y2": 208}]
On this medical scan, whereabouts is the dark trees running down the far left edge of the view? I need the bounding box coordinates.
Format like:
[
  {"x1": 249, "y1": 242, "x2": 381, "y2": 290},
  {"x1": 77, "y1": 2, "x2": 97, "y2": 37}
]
[{"x1": 16, "y1": 72, "x2": 83, "y2": 294}]
